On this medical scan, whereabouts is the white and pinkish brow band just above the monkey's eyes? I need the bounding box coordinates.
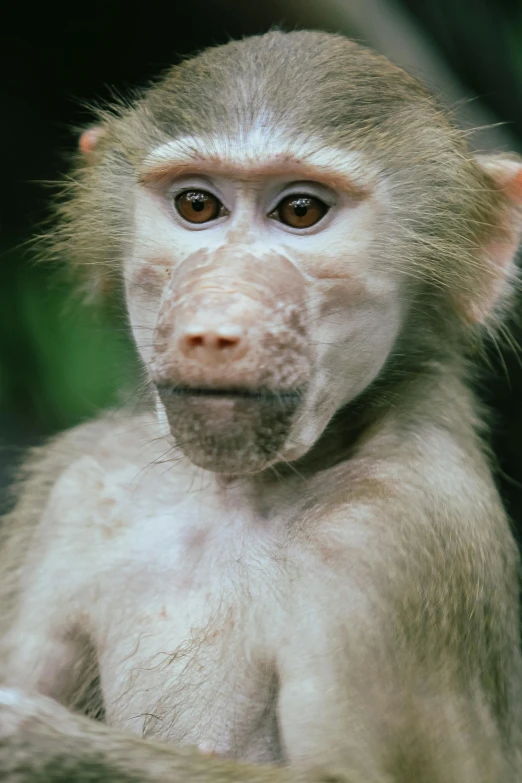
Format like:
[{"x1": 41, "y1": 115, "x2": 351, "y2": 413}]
[{"x1": 139, "y1": 130, "x2": 376, "y2": 195}]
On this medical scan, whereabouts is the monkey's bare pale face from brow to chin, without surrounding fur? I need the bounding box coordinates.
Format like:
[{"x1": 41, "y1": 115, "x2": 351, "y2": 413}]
[{"x1": 125, "y1": 134, "x2": 402, "y2": 473}]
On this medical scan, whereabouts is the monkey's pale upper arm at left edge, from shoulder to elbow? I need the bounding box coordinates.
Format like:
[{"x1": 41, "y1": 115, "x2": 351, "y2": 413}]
[{"x1": 0, "y1": 419, "x2": 133, "y2": 711}]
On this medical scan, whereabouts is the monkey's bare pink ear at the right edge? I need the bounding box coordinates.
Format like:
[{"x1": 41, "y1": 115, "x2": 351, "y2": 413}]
[{"x1": 463, "y1": 155, "x2": 522, "y2": 323}]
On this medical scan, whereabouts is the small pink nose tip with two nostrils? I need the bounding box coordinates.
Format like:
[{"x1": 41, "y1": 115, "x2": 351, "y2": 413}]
[{"x1": 178, "y1": 324, "x2": 247, "y2": 361}]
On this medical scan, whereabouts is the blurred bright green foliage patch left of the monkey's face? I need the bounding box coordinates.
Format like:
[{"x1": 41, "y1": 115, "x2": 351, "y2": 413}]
[{"x1": 0, "y1": 261, "x2": 142, "y2": 434}]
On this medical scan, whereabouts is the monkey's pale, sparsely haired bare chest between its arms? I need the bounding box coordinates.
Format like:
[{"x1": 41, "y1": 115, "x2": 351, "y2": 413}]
[{"x1": 79, "y1": 480, "x2": 291, "y2": 761}]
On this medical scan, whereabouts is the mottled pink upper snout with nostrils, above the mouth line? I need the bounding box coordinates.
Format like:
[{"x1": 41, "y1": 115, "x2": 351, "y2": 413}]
[{"x1": 151, "y1": 248, "x2": 310, "y2": 390}]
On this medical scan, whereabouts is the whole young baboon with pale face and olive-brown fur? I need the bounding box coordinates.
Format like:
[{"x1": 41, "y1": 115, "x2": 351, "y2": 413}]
[{"x1": 0, "y1": 26, "x2": 522, "y2": 783}]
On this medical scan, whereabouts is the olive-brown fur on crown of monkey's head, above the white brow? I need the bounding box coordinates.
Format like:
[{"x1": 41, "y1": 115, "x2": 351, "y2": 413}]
[{"x1": 141, "y1": 32, "x2": 429, "y2": 159}]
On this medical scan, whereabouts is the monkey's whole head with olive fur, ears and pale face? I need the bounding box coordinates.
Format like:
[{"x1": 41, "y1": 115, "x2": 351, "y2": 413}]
[{"x1": 68, "y1": 32, "x2": 521, "y2": 474}]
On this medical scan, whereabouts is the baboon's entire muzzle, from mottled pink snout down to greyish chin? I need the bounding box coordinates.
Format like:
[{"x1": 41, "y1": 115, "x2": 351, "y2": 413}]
[{"x1": 146, "y1": 246, "x2": 310, "y2": 472}]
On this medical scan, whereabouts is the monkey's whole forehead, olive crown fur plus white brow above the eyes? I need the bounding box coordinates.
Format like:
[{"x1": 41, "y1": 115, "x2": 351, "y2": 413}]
[{"x1": 132, "y1": 32, "x2": 441, "y2": 193}]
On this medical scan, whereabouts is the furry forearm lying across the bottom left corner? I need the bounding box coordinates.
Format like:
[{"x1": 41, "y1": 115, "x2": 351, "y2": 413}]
[{"x1": 0, "y1": 689, "x2": 304, "y2": 783}]
